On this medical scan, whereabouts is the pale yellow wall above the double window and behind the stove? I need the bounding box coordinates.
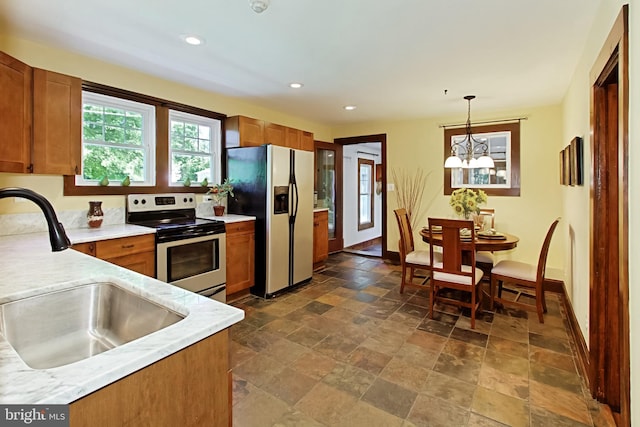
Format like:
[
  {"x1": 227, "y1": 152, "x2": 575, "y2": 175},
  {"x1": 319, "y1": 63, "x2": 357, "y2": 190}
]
[{"x1": 0, "y1": 35, "x2": 331, "y2": 213}]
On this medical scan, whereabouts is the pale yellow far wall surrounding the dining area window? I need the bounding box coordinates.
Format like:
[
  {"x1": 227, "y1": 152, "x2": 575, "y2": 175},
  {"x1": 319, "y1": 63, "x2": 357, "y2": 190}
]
[{"x1": 334, "y1": 104, "x2": 564, "y2": 278}]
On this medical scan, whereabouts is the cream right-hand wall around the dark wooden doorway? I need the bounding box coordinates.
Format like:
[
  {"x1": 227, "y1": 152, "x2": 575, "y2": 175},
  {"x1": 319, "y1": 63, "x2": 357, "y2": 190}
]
[{"x1": 558, "y1": 0, "x2": 640, "y2": 425}]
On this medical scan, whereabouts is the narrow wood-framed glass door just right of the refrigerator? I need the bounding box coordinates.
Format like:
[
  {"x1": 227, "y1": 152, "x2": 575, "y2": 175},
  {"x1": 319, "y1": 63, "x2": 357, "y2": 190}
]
[{"x1": 314, "y1": 141, "x2": 344, "y2": 253}]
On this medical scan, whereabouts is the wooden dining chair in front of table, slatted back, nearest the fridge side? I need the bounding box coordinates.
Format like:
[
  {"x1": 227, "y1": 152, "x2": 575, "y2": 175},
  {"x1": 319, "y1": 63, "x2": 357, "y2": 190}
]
[{"x1": 429, "y1": 218, "x2": 483, "y2": 329}]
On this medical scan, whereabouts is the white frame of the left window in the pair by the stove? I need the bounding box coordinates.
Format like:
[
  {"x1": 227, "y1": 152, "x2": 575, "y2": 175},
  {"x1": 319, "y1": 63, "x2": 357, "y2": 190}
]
[{"x1": 75, "y1": 91, "x2": 156, "y2": 186}]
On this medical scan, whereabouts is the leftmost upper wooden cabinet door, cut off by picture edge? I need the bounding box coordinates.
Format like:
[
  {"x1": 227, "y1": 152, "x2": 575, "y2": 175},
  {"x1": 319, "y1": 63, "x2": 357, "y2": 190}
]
[{"x1": 0, "y1": 52, "x2": 33, "y2": 173}]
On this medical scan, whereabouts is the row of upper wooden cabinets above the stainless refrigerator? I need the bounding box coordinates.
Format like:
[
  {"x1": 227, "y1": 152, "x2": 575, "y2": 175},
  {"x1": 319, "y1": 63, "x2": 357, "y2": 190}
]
[{"x1": 225, "y1": 116, "x2": 314, "y2": 151}]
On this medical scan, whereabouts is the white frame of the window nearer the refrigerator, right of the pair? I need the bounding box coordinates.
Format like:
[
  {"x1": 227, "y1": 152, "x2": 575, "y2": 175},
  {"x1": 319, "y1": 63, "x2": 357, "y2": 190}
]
[{"x1": 167, "y1": 109, "x2": 222, "y2": 187}]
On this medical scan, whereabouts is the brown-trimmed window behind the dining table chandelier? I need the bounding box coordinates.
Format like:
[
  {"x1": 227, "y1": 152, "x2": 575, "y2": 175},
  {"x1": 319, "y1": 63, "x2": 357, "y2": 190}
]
[{"x1": 444, "y1": 122, "x2": 520, "y2": 196}]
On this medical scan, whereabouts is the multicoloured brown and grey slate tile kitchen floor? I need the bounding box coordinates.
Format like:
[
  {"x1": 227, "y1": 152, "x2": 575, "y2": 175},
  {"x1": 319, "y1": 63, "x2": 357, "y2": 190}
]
[{"x1": 231, "y1": 253, "x2": 614, "y2": 427}]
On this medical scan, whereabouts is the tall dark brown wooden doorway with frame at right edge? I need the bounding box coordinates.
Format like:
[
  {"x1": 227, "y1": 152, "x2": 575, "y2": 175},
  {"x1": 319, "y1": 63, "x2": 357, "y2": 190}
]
[{"x1": 588, "y1": 5, "x2": 631, "y2": 426}]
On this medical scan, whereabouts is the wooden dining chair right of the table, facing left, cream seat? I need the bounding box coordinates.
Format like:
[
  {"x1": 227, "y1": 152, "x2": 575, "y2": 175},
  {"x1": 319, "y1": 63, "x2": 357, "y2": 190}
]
[{"x1": 490, "y1": 218, "x2": 560, "y2": 323}]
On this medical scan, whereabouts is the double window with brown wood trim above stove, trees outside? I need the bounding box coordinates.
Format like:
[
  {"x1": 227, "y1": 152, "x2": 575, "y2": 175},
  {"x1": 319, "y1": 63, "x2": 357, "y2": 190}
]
[{"x1": 64, "y1": 82, "x2": 226, "y2": 196}]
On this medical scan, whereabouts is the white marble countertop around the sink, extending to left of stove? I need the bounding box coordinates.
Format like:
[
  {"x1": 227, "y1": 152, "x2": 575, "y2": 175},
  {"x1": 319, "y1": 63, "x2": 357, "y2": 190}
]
[{"x1": 0, "y1": 232, "x2": 244, "y2": 404}]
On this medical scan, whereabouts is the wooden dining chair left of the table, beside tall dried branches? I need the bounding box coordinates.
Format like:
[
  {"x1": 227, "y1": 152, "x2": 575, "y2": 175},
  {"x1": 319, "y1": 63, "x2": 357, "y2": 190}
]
[{"x1": 393, "y1": 208, "x2": 441, "y2": 293}]
